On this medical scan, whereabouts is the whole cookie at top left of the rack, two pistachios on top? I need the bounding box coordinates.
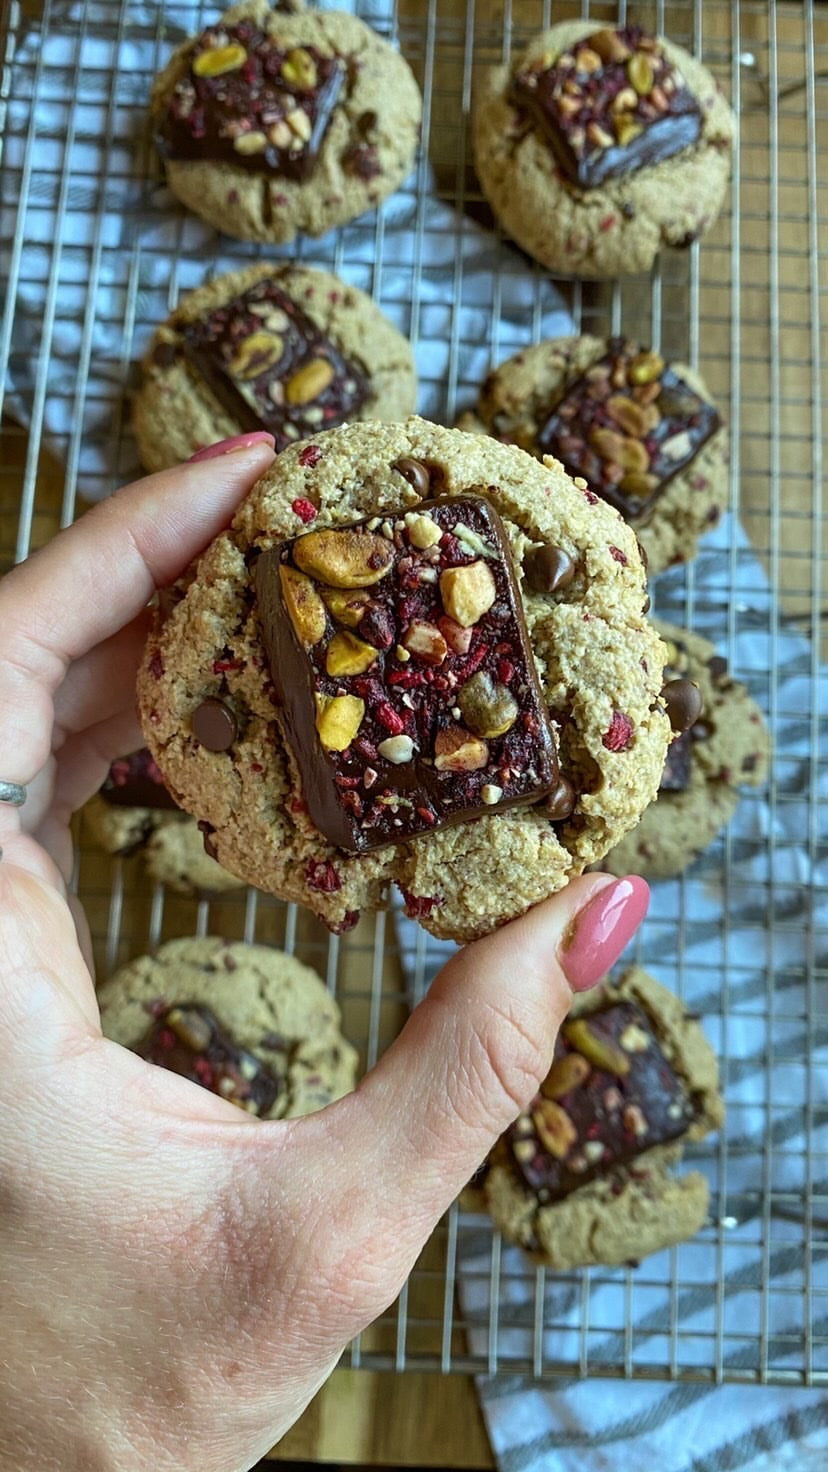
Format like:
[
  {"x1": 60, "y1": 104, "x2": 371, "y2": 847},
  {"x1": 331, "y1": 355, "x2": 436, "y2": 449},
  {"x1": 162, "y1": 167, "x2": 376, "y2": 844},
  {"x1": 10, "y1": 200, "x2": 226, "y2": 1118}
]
[{"x1": 152, "y1": 0, "x2": 421, "y2": 241}]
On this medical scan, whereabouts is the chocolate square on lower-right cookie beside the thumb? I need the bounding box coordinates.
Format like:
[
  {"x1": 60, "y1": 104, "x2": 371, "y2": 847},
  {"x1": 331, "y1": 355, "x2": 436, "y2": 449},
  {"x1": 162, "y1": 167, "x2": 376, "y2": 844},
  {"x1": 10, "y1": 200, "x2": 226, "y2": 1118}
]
[{"x1": 507, "y1": 1001, "x2": 695, "y2": 1201}]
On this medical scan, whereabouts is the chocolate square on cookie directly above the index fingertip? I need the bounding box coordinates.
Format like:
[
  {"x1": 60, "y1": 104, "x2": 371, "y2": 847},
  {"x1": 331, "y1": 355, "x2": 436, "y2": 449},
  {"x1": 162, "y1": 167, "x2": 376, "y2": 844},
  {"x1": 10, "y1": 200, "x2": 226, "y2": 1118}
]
[{"x1": 181, "y1": 278, "x2": 368, "y2": 450}]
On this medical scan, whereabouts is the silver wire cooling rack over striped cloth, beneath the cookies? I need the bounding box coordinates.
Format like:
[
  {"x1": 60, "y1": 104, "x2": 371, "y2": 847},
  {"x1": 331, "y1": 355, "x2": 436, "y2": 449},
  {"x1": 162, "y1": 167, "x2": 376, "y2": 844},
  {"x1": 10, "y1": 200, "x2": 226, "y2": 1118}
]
[{"x1": 0, "y1": 0, "x2": 828, "y2": 1384}]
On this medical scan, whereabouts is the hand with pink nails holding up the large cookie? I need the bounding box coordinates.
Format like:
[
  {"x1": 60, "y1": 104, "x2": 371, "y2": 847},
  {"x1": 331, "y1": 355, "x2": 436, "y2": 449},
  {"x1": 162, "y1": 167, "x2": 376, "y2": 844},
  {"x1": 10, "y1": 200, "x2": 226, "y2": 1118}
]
[{"x1": 0, "y1": 442, "x2": 647, "y2": 1472}]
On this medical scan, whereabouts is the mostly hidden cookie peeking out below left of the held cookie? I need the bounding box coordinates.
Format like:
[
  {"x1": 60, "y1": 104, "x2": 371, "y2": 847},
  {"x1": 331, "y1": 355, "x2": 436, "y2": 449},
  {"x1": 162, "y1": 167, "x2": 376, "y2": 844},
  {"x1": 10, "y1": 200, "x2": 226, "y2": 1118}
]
[{"x1": 84, "y1": 748, "x2": 245, "y2": 895}]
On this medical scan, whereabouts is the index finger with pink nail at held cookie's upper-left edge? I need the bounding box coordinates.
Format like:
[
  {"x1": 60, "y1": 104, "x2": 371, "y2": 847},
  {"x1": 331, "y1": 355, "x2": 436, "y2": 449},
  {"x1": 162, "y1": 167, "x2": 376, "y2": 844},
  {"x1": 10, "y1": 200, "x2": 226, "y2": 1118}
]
[{"x1": 0, "y1": 442, "x2": 273, "y2": 786}]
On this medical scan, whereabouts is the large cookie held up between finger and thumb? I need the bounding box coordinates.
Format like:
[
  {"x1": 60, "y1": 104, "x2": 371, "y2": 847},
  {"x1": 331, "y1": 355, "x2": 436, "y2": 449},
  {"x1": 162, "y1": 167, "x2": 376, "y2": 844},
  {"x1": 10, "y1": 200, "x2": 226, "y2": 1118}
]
[{"x1": 138, "y1": 418, "x2": 669, "y2": 941}]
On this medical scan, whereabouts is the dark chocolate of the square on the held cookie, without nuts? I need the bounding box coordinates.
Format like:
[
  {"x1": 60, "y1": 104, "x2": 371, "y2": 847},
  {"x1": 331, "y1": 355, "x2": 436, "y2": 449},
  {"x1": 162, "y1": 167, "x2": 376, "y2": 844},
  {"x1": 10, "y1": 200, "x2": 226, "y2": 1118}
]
[{"x1": 256, "y1": 496, "x2": 558, "y2": 852}]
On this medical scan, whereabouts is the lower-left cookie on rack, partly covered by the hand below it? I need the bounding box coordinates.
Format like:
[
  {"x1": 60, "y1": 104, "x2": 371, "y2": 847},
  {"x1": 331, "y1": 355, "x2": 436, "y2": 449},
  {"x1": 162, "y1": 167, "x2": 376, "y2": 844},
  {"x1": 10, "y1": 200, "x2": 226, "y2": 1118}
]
[{"x1": 97, "y1": 936, "x2": 357, "y2": 1119}]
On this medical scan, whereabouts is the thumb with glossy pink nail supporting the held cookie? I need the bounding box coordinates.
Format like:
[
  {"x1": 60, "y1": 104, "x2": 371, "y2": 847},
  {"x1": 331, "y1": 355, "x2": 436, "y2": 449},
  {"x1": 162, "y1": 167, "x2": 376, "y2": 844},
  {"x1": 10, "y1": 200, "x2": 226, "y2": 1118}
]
[{"x1": 331, "y1": 874, "x2": 650, "y2": 1256}]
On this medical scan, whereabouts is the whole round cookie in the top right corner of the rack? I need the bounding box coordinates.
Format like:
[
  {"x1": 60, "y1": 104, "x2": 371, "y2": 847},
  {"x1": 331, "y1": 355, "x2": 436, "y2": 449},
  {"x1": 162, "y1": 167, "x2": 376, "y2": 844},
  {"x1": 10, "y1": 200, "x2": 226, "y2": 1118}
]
[{"x1": 473, "y1": 21, "x2": 735, "y2": 278}]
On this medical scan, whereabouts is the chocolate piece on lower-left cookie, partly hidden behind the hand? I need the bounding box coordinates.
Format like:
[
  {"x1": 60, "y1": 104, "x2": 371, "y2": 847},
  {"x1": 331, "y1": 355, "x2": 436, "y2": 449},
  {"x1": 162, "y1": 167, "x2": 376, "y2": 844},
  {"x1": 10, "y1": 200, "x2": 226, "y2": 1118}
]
[{"x1": 137, "y1": 1002, "x2": 278, "y2": 1114}]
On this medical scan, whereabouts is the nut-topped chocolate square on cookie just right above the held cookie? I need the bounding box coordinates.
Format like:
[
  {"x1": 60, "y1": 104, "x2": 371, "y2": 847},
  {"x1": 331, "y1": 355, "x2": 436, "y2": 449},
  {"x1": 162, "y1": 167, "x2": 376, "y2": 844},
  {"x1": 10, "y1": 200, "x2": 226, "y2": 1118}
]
[{"x1": 536, "y1": 337, "x2": 722, "y2": 524}]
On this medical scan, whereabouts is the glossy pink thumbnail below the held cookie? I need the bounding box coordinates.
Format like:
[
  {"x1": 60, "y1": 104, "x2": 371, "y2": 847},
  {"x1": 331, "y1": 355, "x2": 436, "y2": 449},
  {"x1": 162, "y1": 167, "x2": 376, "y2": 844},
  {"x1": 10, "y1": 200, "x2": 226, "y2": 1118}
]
[{"x1": 560, "y1": 874, "x2": 650, "y2": 992}]
